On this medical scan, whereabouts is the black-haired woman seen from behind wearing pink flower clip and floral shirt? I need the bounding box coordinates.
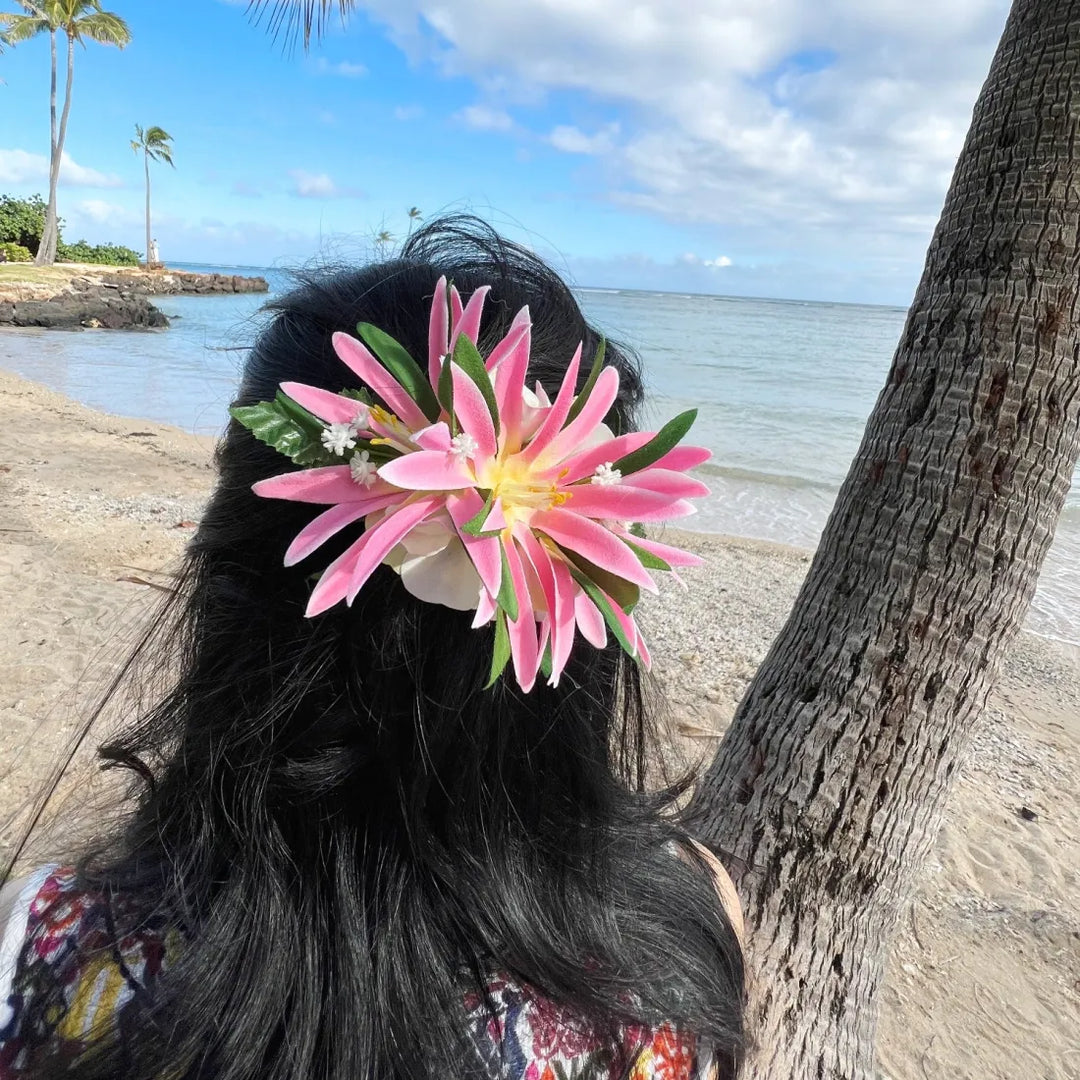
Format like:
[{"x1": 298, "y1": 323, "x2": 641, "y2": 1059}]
[{"x1": 0, "y1": 219, "x2": 743, "y2": 1080}]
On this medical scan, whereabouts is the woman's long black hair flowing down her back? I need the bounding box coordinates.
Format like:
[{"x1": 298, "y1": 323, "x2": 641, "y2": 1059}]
[{"x1": 12, "y1": 218, "x2": 743, "y2": 1080}]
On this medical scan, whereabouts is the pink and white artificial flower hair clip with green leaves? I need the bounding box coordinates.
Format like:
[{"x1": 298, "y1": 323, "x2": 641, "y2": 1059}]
[{"x1": 230, "y1": 278, "x2": 710, "y2": 691}]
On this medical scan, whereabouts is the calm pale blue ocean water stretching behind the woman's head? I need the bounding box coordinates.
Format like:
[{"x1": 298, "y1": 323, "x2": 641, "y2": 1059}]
[{"x1": 0, "y1": 264, "x2": 1080, "y2": 644}]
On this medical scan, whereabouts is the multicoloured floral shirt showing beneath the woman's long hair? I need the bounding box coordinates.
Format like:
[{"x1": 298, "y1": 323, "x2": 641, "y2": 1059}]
[{"x1": 0, "y1": 868, "x2": 707, "y2": 1080}]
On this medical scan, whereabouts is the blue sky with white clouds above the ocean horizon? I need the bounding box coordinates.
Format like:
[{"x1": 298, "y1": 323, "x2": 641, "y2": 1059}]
[{"x1": 0, "y1": 0, "x2": 1009, "y2": 306}]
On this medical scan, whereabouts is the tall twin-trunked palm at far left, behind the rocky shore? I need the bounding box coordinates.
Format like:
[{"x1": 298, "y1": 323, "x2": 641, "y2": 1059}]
[{"x1": 0, "y1": 0, "x2": 131, "y2": 266}]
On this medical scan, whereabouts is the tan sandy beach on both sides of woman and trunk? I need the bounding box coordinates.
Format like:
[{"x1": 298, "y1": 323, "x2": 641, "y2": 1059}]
[{"x1": 0, "y1": 373, "x2": 1080, "y2": 1080}]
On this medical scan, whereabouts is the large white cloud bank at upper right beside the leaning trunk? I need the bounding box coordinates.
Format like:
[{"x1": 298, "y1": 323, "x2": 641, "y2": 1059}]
[{"x1": 359, "y1": 0, "x2": 1010, "y2": 274}]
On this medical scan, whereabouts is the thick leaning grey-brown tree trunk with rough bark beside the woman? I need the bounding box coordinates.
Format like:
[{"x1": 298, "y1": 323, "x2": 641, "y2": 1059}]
[{"x1": 694, "y1": 0, "x2": 1080, "y2": 1080}]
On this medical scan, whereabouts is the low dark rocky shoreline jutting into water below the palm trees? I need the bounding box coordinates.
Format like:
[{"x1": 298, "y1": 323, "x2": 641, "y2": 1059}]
[{"x1": 0, "y1": 266, "x2": 270, "y2": 330}]
